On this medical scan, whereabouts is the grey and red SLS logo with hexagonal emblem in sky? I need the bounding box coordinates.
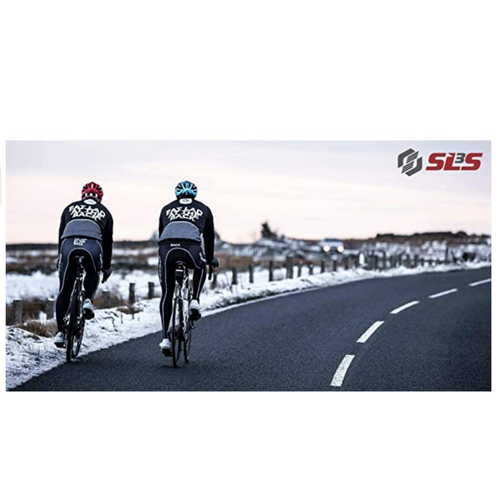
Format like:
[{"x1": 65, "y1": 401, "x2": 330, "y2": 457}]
[{"x1": 398, "y1": 149, "x2": 483, "y2": 176}]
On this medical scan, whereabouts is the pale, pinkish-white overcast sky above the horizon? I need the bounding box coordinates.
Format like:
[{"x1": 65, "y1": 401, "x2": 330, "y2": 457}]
[{"x1": 6, "y1": 141, "x2": 491, "y2": 243}]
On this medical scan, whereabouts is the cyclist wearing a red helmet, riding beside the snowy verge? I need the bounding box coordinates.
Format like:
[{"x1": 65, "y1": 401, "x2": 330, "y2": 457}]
[{"x1": 54, "y1": 182, "x2": 113, "y2": 347}]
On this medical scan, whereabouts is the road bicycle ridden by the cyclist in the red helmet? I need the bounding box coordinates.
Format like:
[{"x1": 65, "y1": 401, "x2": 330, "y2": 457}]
[{"x1": 64, "y1": 255, "x2": 86, "y2": 363}]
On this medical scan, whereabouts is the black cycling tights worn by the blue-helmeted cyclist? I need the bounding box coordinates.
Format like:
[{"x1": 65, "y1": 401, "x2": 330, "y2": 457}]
[{"x1": 158, "y1": 243, "x2": 207, "y2": 336}]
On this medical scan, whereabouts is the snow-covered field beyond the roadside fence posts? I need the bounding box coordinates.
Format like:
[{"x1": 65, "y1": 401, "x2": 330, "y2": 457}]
[{"x1": 6, "y1": 238, "x2": 491, "y2": 304}]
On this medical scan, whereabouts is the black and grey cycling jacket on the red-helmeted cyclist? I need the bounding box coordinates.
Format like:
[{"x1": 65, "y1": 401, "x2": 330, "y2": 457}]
[{"x1": 59, "y1": 198, "x2": 113, "y2": 269}]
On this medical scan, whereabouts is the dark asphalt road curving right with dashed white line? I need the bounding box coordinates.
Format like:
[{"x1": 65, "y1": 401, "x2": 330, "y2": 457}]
[{"x1": 16, "y1": 268, "x2": 491, "y2": 391}]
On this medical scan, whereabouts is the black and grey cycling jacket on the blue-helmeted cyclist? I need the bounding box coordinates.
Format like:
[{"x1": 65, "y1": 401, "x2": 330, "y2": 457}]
[{"x1": 158, "y1": 198, "x2": 215, "y2": 262}]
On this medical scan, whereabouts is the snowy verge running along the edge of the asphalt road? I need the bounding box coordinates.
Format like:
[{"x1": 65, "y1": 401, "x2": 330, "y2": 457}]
[{"x1": 6, "y1": 262, "x2": 491, "y2": 389}]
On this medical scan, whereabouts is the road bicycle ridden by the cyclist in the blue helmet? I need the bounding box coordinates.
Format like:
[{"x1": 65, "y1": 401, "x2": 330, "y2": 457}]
[{"x1": 170, "y1": 261, "x2": 213, "y2": 368}]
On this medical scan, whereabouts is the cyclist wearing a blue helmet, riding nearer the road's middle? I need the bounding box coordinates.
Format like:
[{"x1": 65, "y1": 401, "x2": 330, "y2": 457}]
[{"x1": 158, "y1": 181, "x2": 215, "y2": 351}]
